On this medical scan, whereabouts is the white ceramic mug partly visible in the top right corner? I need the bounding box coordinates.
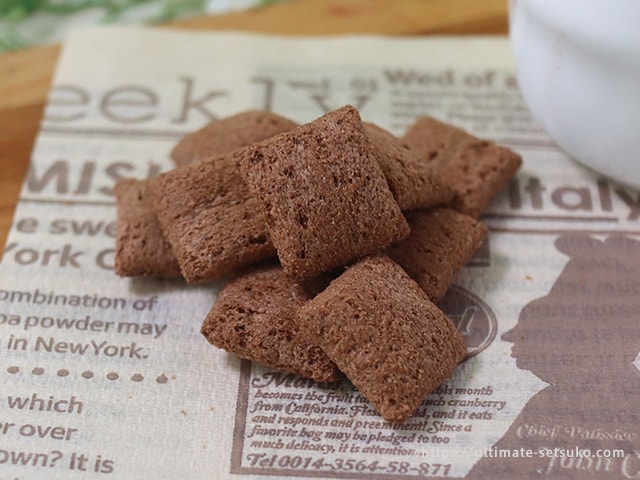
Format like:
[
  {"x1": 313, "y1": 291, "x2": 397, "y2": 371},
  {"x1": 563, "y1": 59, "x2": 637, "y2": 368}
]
[{"x1": 509, "y1": 0, "x2": 640, "y2": 188}]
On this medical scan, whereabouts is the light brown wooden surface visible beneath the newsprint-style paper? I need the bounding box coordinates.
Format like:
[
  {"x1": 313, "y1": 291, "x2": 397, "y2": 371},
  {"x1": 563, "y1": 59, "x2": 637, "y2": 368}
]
[{"x1": 0, "y1": 0, "x2": 508, "y2": 255}]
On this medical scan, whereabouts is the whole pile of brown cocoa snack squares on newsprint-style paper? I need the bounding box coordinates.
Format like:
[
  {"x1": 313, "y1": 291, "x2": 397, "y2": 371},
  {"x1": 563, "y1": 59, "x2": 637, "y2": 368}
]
[{"x1": 114, "y1": 105, "x2": 521, "y2": 422}]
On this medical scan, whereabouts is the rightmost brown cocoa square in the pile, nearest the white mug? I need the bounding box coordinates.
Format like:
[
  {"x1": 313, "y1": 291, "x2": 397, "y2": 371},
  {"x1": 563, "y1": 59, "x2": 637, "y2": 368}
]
[{"x1": 403, "y1": 117, "x2": 522, "y2": 217}]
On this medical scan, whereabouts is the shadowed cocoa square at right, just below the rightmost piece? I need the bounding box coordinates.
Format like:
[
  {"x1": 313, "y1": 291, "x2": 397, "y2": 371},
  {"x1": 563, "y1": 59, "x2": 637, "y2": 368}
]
[{"x1": 387, "y1": 208, "x2": 488, "y2": 303}]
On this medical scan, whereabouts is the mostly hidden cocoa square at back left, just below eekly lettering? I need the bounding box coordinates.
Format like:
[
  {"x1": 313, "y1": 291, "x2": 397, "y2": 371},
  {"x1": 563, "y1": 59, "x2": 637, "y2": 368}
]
[{"x1": 171, "y1": 110, "x2": 297, "y2": 166}]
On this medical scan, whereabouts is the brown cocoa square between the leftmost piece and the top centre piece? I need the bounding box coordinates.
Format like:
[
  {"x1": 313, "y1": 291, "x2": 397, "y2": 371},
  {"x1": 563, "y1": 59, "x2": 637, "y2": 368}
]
[{"x1": 148, "y1": 154, "x2": 276, "y2": 283}]
